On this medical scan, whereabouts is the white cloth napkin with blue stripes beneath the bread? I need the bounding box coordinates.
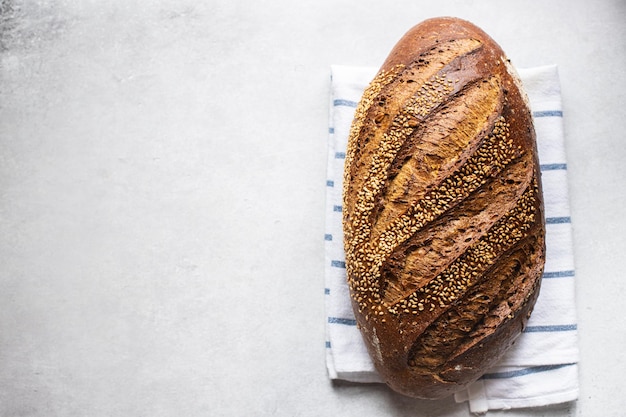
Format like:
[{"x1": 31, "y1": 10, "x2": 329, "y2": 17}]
[{"x1": 324, "y1": 66, "x2": 578, "y2": 413}]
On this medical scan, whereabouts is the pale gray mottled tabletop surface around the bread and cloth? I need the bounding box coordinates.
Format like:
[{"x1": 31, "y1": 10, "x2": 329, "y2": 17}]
[{"x1": 0, "y1": 0, "x2": 626, "y2": 417}]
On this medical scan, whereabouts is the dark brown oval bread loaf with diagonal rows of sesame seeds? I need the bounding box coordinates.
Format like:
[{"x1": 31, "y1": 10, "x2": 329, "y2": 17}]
[{"x1": 343, "y1": 18, "x2": 545, "y2": 399}]
